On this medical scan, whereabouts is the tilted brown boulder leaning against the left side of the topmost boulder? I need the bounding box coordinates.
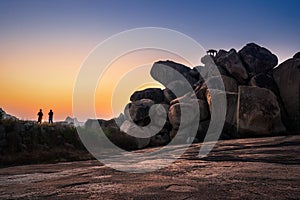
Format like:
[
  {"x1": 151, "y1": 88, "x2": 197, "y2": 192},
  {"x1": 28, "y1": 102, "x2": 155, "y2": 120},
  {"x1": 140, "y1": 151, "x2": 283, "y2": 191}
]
[{"x1": 215, "y1": 49, "x2": 248, "y2": 84}]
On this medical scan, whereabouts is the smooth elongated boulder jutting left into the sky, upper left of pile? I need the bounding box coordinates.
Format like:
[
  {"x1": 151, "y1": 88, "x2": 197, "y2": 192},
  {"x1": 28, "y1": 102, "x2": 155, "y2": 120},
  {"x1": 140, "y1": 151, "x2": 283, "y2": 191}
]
[{"x1": 150, "y1": 60, "x2": 197, "y2": 86}]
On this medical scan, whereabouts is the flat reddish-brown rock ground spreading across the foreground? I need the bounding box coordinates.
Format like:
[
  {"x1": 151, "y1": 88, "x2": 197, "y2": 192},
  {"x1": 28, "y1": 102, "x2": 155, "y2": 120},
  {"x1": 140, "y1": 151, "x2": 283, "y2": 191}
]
[{"x1": 0, "y1": 136, "x2": 300, "y2": 200}]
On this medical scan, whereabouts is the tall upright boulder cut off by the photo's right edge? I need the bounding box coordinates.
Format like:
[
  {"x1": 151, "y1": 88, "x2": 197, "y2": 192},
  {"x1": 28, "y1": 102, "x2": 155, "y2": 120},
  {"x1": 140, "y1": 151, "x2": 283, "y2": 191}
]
[{"x1": 273, "y1": 58, "x2": 300, "y2": 132}]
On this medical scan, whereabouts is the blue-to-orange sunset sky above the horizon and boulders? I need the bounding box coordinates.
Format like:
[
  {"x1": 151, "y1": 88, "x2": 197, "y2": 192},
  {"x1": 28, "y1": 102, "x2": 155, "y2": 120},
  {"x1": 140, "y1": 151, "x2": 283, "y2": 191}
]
[{"x1": 0, "y1": 0, "x2": 300, "y2": 121}]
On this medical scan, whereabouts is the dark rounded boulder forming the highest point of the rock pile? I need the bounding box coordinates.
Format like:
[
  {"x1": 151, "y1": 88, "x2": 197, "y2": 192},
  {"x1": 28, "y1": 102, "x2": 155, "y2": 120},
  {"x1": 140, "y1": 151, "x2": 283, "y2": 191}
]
[{"x1": 238, "y1": 43, "x2": 278, "y2": 76}]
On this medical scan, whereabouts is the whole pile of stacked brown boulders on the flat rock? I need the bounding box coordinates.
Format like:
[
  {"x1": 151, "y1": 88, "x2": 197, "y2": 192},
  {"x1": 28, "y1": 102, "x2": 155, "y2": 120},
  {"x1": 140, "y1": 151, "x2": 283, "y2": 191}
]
[{"x1": 106, "y1": 43, "x2": 300, "y2": 148}]
